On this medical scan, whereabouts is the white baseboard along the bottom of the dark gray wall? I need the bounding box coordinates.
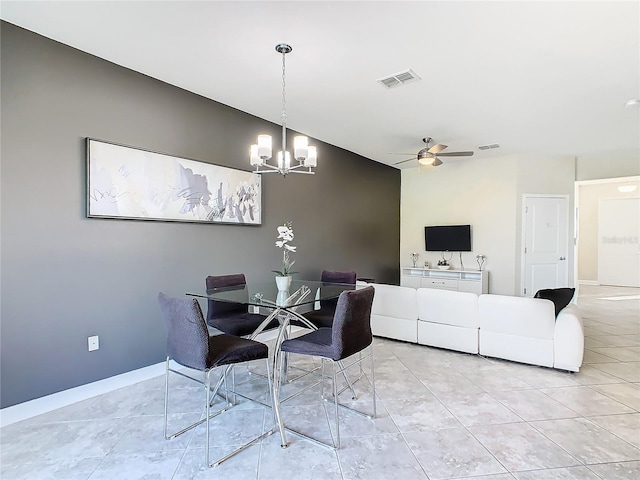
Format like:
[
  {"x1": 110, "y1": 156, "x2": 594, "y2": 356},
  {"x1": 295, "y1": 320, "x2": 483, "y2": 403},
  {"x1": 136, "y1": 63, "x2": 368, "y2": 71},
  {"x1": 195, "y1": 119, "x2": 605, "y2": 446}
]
[{"x1": 0, "y1": 328, "x2": 288, "y2": 427}]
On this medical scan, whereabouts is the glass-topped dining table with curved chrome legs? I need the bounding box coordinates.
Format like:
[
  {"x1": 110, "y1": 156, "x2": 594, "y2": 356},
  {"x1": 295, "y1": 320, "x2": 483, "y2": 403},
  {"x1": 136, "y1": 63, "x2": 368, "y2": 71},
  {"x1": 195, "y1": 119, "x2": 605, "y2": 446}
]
[{"x1": 187, "y1": 280, "x2": 356, "y2": 448}]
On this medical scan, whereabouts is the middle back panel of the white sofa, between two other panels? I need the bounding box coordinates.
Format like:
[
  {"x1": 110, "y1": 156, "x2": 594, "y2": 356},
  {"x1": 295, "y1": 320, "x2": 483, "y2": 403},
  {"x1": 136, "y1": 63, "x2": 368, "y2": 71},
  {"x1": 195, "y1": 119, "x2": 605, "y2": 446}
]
[{"x1": 417, "y1": 288, "x2": 479, "y2": 328}]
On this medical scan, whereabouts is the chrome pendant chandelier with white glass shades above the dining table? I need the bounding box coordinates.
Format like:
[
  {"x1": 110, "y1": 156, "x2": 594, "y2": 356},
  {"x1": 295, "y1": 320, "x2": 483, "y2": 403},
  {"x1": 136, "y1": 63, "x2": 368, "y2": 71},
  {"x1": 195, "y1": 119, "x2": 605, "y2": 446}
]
[{"x1": 250, "y1": 43, "x2": 318, "y2": 176}]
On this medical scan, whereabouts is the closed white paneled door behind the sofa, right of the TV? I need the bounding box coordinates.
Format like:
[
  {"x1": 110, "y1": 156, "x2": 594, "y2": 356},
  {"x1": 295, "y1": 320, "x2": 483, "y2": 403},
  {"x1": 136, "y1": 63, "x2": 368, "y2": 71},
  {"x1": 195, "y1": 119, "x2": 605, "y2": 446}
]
[{"x1": 522, "y1": 195, "x2": 569, "y2": 296}]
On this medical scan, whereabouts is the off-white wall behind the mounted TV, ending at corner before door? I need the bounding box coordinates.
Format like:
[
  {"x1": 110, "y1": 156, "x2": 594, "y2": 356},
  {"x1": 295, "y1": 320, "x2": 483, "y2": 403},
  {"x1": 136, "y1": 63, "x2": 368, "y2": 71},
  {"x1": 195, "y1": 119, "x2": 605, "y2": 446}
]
[{"x1": 400, "y1": 157, "x2": 517, "y2": 294}]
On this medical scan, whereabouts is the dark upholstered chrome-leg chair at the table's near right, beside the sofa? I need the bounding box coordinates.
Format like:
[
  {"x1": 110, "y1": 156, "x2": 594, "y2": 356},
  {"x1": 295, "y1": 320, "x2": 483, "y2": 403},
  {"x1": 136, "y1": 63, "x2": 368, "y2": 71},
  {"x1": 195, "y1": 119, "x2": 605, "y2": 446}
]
[{"x1": 280, "y1": 287, "x2": 376, "y2": 448}]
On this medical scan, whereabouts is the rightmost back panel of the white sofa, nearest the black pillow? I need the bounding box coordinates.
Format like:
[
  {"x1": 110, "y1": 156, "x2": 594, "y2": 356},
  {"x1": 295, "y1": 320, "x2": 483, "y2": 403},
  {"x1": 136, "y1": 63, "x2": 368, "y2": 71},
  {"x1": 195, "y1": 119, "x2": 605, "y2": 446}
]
[{"x1": 478, "y1": 294, "x2": 556, "y2": 340}]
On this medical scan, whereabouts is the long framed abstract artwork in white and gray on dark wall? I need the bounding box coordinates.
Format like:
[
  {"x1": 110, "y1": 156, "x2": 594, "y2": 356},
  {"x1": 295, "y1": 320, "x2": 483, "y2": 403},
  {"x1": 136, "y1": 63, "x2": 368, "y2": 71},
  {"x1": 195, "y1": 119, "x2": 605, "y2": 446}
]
[{"x1": 87, "y1": 138, "x2": 262, "y2": 225}]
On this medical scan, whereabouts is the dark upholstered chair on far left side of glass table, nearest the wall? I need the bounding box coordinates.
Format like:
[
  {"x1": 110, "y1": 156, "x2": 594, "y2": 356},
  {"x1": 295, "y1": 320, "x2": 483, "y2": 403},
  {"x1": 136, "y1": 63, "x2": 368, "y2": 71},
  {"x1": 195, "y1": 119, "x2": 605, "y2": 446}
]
[{"x1": 205, "y1": 273, "x2": 278, "y2": 337}]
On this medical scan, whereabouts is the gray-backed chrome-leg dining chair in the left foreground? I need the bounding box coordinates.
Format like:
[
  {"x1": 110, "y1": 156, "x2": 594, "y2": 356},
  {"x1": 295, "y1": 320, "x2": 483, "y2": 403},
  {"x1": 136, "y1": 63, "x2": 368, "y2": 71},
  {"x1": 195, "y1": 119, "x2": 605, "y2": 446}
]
[{"x1": 158, "y1": 293, "x2": 273, "y2": 467}]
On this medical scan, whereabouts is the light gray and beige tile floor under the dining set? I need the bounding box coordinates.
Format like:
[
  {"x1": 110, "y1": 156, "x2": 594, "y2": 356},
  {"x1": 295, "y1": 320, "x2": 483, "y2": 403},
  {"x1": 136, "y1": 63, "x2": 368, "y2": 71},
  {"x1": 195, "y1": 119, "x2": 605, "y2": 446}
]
[{"x1": 0, "y1": 286, "x2": 640, "y2": 480}]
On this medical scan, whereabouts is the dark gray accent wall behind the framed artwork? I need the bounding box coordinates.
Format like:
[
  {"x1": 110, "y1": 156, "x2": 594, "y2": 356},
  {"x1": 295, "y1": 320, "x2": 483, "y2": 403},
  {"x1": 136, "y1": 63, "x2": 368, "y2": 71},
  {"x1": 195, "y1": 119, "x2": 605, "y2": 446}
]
[{"x1": 0, "y1": 22, "x2": 400, "y2": 408}]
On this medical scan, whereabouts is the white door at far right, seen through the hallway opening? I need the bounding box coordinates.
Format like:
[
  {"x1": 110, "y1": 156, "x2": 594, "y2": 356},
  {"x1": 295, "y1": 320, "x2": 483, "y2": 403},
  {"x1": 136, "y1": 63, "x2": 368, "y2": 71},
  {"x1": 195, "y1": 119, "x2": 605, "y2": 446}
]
[{"x1": 598, "y1": 197, "x2": 640, "y2": 287}]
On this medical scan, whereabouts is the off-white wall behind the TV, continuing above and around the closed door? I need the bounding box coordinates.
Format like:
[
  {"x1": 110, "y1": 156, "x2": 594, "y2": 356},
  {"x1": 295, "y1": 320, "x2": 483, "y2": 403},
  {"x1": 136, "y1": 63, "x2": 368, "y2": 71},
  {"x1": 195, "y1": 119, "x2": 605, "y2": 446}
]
[{"x1": 400, "y1": 156, "x2": 575, "y2": 295}]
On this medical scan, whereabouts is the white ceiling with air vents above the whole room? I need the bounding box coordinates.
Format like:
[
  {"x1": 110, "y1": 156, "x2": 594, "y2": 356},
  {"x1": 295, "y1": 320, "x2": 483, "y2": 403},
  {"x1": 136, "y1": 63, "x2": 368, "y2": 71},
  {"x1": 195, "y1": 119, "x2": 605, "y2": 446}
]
[{"x1": 0, "y1": 1, "x2": 640, "y2": 168}]
